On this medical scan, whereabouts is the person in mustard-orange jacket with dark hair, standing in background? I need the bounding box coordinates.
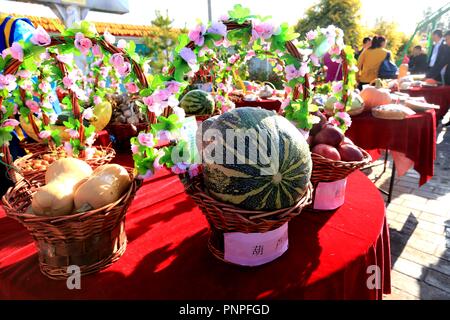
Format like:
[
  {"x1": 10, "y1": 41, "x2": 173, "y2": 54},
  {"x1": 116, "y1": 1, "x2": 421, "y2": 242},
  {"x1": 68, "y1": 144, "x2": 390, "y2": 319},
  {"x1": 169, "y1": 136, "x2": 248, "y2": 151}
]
[{"x1": 357, "y1": 36, "x2": 389, "y2": 90}]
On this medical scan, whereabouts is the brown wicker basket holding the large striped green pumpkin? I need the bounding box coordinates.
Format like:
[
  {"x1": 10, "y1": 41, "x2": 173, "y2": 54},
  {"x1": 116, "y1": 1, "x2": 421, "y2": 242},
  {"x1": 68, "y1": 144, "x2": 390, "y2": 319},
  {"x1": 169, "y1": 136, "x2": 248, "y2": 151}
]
[{"x1": 180, "y1": 175, "x2": 312, "y2": 263}]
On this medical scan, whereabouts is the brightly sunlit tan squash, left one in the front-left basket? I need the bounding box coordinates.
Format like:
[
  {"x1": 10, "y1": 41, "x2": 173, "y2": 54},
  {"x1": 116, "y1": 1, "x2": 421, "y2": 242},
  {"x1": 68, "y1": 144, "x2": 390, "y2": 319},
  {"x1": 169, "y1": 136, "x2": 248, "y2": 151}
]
[{"x1": 31, "y1": 158, "x2": 92, "y2": 216}]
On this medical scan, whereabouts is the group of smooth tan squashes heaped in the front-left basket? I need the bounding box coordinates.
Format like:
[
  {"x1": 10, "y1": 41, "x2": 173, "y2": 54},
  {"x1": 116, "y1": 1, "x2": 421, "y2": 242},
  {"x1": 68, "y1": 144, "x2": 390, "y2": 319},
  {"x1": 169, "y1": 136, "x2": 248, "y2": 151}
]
[{"x1": 31, "y1": 158, "x2": 131, "y2": 217}]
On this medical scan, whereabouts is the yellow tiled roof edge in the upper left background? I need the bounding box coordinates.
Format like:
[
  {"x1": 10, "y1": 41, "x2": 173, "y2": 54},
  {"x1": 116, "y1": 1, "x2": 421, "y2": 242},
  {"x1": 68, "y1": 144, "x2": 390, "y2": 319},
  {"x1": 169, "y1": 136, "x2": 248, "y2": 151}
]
[{"x1": 0, "y1": 13, "x2": 171, "y2": 38}]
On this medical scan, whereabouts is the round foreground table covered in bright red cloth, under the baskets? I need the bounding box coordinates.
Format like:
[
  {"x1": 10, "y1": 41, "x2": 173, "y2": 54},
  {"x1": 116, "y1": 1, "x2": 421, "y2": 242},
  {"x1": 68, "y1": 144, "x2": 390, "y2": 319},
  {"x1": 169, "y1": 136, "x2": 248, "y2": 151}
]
[{"x1": 0, "y1": 171, "x2": 390, "y2": 300}]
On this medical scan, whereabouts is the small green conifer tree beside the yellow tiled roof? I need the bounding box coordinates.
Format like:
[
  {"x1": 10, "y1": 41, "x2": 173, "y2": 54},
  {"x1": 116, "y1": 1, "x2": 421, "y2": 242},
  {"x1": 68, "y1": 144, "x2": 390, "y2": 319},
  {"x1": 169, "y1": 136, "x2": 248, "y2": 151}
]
[{"x1": 144, "y1": 11, "x2": 180, "y2": 73}]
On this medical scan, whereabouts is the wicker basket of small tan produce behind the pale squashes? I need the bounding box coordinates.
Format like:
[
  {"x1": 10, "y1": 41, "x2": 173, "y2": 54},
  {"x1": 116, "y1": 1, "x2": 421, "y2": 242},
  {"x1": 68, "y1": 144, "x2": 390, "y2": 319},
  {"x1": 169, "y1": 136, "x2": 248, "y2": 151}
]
[{"x1": 13, "y1": 146, "x2": 116, "y2": 186}]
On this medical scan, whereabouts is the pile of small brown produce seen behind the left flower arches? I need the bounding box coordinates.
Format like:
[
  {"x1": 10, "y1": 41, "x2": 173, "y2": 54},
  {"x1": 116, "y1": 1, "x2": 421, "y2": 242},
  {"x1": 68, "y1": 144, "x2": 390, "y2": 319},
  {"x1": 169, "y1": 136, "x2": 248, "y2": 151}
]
[{"x1": 108, "y1": 94, "x2": 145, "y2": 125}]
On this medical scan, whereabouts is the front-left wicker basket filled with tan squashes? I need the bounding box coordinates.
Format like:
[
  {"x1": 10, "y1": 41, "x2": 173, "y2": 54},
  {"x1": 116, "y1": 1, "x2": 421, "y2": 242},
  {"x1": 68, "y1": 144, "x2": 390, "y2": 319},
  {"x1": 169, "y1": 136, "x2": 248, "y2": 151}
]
[{"x1": 2, "y1": 158, "x2": 139, "y2": 279}]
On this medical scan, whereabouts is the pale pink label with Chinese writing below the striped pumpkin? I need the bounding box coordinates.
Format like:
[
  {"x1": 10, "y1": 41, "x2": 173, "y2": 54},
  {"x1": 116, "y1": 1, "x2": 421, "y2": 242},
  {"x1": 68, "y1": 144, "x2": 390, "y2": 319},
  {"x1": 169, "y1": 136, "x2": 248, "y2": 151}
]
[{"x1": 224, "y1": 222, "x2": 289, "y2": 266}]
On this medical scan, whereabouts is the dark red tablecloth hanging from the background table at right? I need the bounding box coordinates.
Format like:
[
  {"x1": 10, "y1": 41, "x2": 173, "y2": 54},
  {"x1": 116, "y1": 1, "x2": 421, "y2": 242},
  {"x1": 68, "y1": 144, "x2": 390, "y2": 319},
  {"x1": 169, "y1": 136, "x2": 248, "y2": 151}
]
[{"x1": 346, "y1": 110, "x2": 436, "y2": 185}]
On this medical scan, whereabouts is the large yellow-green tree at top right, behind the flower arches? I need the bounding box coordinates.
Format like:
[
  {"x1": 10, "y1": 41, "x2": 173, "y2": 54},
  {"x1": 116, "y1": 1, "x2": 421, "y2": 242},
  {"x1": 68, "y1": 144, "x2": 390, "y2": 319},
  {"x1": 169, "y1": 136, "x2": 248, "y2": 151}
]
[{"x1": 295, "y1": 0, "x2": 366, "y2": 46}]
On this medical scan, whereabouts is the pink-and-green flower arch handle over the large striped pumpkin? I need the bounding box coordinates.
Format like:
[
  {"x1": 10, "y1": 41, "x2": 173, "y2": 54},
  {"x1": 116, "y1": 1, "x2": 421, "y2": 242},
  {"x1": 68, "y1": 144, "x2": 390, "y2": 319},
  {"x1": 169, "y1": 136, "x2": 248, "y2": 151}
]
[{"x1": 131, "y1": 5, "x2": 352, "y2": 179}]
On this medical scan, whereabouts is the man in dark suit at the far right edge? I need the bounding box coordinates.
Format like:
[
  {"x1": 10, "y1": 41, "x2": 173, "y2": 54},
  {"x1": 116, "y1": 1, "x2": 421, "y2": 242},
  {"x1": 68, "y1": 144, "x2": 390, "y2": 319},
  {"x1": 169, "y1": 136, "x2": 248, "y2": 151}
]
[{"x1": 426, "y1": 29, "x2": 449, "y2": 82}]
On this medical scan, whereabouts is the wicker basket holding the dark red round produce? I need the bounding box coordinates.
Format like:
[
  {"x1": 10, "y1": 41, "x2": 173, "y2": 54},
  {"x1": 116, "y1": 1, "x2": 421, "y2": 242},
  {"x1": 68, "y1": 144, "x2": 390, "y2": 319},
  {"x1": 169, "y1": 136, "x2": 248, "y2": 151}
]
[{"x1": 306, "y1": 147, "x2": 372, "y2": 212}]
